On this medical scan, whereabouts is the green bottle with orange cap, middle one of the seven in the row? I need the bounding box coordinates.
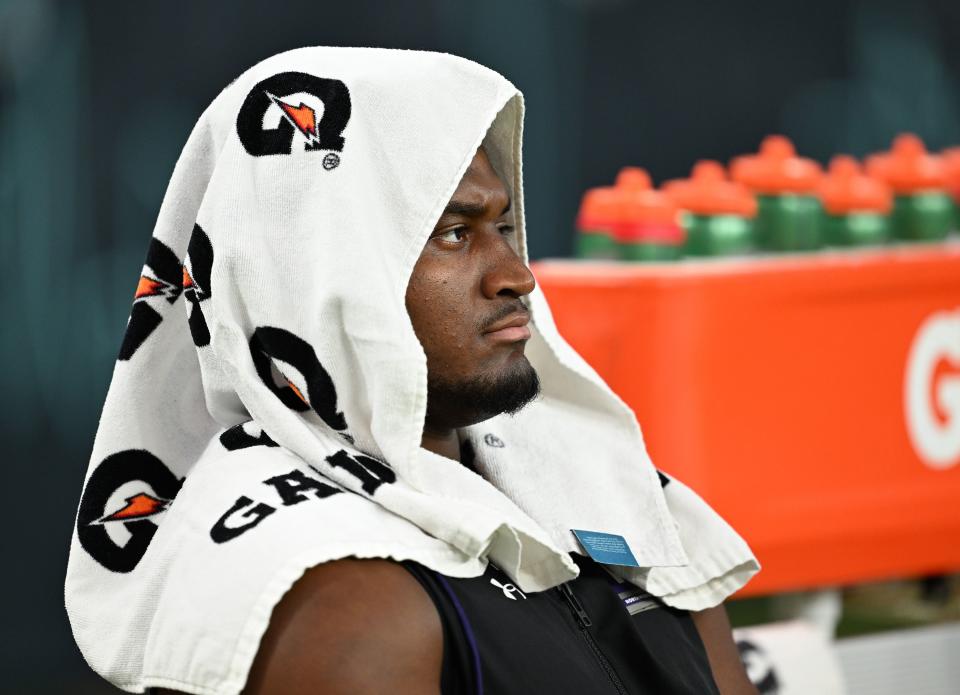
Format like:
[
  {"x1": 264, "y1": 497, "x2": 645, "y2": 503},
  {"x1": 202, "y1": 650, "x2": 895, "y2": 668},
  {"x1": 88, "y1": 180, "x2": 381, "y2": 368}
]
[{"x1": 730, "y1": 135, "x2": 823, "y2": 251}]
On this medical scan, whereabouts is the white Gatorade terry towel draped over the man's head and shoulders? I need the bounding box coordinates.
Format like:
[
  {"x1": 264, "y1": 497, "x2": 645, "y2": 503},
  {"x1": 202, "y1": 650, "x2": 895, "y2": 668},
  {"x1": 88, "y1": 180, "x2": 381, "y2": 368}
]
[{"x1": 66, "y1": 48, "x2": 758, "y2": 695}]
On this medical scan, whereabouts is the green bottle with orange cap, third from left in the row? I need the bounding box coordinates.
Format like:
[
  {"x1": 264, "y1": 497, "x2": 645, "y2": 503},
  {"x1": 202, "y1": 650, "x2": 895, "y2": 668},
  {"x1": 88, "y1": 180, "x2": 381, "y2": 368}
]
[{"x1": 663, "y1": 160, "x2": 757, "y2": 256}]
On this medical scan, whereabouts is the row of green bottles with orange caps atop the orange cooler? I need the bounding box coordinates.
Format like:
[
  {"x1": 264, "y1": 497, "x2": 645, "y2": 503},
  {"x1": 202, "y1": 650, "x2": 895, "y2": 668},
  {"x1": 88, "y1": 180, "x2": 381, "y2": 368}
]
[{"x1": 577, "y1": 134, "x2": 960, "y2": 261}]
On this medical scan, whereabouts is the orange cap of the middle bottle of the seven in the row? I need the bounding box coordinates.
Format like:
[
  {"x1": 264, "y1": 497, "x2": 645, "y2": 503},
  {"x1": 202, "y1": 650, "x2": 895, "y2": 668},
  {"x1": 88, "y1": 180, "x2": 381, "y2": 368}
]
[{"x1": 730, "y1": 135, "x2": 823, "y2": 194}]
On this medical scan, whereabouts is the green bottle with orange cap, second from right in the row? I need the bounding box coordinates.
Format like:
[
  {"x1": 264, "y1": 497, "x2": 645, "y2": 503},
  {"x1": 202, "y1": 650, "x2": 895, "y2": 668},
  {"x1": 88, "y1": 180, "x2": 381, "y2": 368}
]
[{"x1": 867, "y1": 133, "x2": 954, "y2": 241}]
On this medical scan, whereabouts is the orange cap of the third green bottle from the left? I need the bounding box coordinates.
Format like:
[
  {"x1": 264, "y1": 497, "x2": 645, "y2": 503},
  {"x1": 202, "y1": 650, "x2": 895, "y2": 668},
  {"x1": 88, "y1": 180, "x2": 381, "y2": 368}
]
[{"x1": 663, "y1": 159, "x2": 757, "y2": 217}]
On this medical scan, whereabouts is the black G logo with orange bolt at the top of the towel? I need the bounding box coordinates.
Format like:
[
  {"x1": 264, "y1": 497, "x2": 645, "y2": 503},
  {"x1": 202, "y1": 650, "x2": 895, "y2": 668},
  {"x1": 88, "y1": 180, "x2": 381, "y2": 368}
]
[{"x1": 237, "y1": 72, "x2": 350, "y2": 158}]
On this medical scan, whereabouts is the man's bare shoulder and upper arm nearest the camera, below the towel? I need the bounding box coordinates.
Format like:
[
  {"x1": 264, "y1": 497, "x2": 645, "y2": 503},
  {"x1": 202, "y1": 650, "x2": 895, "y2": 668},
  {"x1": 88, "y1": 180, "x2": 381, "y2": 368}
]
[{"x1": 160, "y1": 558, "x2": 443, "y2": 695}]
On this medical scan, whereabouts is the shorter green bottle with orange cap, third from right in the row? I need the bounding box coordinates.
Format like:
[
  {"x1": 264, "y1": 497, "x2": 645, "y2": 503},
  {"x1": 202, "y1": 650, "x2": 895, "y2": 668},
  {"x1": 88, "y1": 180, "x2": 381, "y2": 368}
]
[{"x1": 820, "y1": 155, "x2": 893, "y2": 246}]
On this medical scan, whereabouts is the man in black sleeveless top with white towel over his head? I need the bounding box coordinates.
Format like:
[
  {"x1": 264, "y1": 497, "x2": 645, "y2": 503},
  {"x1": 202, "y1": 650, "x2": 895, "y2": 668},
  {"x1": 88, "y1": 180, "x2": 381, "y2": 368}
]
[{"x1": 68, "y1": 49, "x2": 755, "y2": 695}]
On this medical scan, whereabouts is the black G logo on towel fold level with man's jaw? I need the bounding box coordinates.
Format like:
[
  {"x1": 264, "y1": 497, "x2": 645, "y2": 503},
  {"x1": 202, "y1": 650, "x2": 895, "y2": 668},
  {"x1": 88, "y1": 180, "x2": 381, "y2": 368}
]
[{"x1": 250, "y1": 326, "x2": 347, "y2": 430}]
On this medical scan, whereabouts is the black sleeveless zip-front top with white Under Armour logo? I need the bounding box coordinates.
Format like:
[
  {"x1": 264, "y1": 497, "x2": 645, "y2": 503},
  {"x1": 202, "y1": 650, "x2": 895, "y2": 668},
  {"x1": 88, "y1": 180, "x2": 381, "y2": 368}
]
[{"x1": 403, "y1": 555, "x2": 719, "y2": 695}]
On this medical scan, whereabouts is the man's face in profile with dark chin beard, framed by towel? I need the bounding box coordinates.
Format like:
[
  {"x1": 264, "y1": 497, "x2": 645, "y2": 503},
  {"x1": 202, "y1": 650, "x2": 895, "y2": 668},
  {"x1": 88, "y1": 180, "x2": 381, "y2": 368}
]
[{"x1": 406, "y1": 149, "x2": 540, "y2": 430}]
